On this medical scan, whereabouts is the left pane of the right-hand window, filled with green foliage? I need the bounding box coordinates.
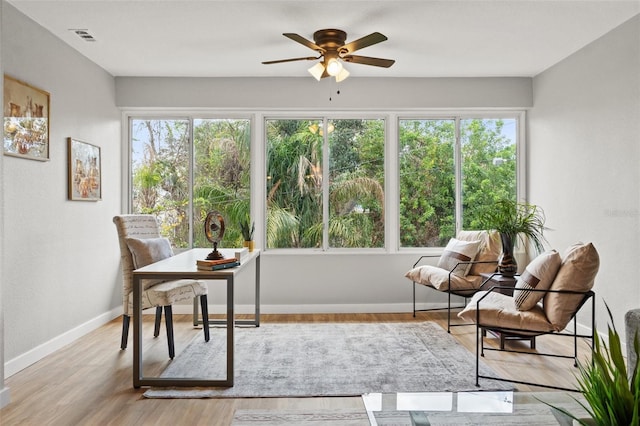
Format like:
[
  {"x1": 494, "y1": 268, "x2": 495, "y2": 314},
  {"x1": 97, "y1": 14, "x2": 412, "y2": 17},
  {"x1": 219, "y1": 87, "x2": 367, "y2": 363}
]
[{"x1": 398, "y1": 120, "x2": 455, "y2": 247}]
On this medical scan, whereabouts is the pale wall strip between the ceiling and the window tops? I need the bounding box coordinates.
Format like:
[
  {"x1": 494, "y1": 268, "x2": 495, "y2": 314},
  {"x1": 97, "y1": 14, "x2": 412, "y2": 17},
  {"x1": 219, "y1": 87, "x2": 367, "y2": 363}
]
[{"x1": 116, "y1": 76, "x2": 532, "y2": 111}]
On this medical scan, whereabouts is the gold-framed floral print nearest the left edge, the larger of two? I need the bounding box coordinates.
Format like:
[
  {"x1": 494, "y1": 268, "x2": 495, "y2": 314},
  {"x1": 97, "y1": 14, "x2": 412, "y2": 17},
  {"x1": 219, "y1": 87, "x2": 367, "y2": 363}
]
[{"x1": 3, "y1": 75, "x2": 50, "y2": 161}]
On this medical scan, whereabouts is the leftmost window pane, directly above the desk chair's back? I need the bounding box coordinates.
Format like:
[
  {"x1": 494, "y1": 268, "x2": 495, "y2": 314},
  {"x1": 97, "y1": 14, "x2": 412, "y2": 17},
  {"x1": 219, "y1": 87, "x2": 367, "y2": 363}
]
[{"x1": 131, "y1": 120, "x2": 189, "y2": 247}]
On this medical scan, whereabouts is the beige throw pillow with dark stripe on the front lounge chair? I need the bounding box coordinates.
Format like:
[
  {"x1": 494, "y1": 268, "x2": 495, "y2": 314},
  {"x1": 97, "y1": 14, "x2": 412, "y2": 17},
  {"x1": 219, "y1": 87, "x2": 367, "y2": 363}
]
[{"x1": 513, "y1": 250, "x2": 562, "y2": 311}]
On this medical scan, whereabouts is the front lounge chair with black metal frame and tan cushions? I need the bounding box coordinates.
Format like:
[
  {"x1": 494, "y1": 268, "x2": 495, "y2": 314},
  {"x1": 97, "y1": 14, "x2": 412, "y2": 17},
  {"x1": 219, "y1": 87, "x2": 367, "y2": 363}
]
[{"x1": 458, "y1": 243, "x2": 599, "y2": 391}]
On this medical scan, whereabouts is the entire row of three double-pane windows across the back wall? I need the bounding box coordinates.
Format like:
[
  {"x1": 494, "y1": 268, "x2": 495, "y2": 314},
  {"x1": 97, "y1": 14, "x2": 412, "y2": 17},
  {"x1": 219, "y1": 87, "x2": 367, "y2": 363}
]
[{"x1": 129, "y1": 113, "x2": 524, "y2": 251}]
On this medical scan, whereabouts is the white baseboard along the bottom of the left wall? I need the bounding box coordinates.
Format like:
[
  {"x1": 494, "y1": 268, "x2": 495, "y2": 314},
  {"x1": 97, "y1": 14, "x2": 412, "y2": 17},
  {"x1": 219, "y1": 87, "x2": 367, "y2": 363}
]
[{"x1": 4, "y1": 307, "x2": 122, "y2": 380}]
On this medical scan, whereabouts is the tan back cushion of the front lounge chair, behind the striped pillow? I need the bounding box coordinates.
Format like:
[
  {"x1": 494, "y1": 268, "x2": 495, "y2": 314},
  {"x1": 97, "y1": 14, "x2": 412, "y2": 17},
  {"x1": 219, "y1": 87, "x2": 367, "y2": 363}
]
[{"x1": 543, "y1": 243, "x2": 600, "y2": 330}]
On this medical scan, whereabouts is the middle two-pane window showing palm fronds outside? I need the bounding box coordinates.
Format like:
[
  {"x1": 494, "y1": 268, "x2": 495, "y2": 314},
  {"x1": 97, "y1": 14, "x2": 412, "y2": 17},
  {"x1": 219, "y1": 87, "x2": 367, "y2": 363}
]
[{"x1": 265, "y1": 118, "x2": 385, "y2": 249}]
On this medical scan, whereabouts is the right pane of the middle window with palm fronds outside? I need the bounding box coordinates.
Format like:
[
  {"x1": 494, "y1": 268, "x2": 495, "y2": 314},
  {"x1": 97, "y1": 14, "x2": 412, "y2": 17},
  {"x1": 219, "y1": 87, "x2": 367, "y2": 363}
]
[{"x1": 327, "y1": 120, "x2": 385, "y2": 248}]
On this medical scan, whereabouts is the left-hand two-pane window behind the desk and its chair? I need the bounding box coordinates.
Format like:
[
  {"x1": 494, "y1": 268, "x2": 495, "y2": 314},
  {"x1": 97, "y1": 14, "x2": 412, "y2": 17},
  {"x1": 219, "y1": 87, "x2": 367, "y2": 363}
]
[{"x1": 130, "y1": 118, "x2": 251, "y2": 248}]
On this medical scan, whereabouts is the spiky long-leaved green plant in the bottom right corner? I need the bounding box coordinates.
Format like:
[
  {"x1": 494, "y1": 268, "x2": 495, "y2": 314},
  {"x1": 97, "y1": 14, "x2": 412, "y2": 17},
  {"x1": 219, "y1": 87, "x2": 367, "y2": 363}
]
[{"x1": 543, "y1": 303, "x2": 640, "y2": 425}]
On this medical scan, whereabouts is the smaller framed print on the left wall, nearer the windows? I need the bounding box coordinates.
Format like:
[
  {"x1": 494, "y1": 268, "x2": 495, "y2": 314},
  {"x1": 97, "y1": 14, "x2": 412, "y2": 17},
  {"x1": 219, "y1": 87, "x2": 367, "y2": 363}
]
[{"x1": 67, "y1": 138, "x2": 102, "y2": 201}]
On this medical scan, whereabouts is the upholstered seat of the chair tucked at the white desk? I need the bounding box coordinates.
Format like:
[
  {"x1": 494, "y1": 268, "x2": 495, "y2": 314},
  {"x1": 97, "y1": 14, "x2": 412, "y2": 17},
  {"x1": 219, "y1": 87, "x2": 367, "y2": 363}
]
[{"x1": 129, "y1": 279, "x2": 208, "y2": 312}]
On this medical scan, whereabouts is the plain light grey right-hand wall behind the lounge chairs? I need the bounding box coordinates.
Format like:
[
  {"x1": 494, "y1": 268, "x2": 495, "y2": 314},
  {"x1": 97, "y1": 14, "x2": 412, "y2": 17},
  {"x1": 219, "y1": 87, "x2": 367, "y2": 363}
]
[{"x1": 528, "y1": 16, "x2": 640, "y2": 340}]
